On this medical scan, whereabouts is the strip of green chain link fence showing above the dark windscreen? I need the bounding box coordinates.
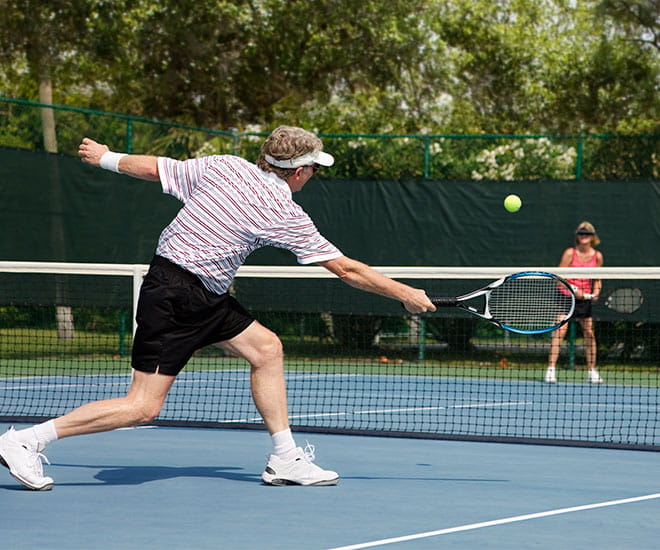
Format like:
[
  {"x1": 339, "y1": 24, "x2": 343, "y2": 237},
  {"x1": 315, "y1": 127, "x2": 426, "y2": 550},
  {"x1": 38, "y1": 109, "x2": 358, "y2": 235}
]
[{"x1": 0, "y1": 97, "x2": 660, "y2": 181}]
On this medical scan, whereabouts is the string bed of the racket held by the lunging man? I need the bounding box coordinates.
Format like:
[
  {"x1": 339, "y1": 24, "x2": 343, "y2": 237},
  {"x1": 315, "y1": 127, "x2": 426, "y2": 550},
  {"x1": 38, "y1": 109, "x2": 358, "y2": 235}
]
[{"x1": 488, "y1": 276, "x2": 573, "y2": 330}]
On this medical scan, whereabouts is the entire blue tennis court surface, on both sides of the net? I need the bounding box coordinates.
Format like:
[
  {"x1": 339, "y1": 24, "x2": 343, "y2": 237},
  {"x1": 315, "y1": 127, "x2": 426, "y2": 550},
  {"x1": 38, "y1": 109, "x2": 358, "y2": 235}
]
[{"x1": 0, "y1": 364, "x2": 660, "y2": 550}]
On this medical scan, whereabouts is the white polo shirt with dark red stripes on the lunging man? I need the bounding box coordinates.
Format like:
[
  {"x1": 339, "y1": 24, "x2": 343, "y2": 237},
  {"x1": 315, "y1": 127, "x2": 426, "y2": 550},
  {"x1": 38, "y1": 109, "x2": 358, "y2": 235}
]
[{"x1": 156, "y1": 155, "x2": 342, "y2": 294}]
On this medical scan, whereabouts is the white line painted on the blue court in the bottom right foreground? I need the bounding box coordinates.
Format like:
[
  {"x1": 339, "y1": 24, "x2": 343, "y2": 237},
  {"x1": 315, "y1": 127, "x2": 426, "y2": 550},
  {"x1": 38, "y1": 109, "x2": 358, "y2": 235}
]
[{"x1": 328, "y1": 493, "x2": 660, "y2": 550}]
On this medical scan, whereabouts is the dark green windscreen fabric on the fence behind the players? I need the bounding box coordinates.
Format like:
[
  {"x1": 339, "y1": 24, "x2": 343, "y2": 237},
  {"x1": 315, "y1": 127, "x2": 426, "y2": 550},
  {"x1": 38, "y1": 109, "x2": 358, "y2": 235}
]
[{"x1": 0, "y1": 148, "x2": 660, "y2": 266}]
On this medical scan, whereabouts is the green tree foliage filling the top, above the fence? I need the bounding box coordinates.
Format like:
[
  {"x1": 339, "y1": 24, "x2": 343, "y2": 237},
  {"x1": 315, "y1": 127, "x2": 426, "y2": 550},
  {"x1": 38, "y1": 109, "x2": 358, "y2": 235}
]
[{"x1": 0, "y1": 0, "x2": 660, "y2": 133}]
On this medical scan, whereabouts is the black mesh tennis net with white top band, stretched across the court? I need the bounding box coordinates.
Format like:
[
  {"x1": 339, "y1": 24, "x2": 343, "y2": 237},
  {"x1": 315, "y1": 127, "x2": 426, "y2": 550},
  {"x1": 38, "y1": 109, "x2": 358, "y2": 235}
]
[{"x1": 0, "y1": 262, "x2": 660, "y2": 450}]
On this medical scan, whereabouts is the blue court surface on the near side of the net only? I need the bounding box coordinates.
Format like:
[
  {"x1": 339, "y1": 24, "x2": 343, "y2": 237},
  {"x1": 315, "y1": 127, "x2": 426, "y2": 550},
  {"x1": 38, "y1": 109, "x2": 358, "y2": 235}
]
[{"x1": 0, "y1": 425, "x2": 660, "y2": 550}]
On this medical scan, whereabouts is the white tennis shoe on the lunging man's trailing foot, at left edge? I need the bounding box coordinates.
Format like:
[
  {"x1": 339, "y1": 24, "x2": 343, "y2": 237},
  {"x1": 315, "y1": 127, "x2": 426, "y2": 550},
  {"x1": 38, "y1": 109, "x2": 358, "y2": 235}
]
[{"x1": 0, "y1": 426, "x2": 53, "y2": 491}]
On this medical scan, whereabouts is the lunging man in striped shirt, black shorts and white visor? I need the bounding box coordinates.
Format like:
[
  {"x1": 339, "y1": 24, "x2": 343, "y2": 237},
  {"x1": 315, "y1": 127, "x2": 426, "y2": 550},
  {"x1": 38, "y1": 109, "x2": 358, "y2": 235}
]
[{"x1": 0, "y1": 126, "x2": 435, "y2": 490}]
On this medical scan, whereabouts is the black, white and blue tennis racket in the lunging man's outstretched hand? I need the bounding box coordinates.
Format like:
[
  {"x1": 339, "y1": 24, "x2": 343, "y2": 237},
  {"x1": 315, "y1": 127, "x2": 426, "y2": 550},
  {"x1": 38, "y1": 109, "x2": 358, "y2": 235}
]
[{"x1": 431, "y1": 271, "x2": 575, "y2": 334}]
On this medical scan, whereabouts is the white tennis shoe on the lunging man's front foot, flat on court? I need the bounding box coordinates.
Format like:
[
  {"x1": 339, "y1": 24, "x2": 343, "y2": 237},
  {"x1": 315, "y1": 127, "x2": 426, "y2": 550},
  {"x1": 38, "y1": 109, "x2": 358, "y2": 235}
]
[{"x1": 261, "y1": 443, "x2": 339, "y2": 485}]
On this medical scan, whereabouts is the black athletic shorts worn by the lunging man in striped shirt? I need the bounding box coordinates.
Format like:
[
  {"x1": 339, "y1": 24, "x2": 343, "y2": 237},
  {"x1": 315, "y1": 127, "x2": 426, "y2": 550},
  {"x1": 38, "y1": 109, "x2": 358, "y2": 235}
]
[{"x1": 132, "y1": 256, "x2": 254, "y2": 376}]
